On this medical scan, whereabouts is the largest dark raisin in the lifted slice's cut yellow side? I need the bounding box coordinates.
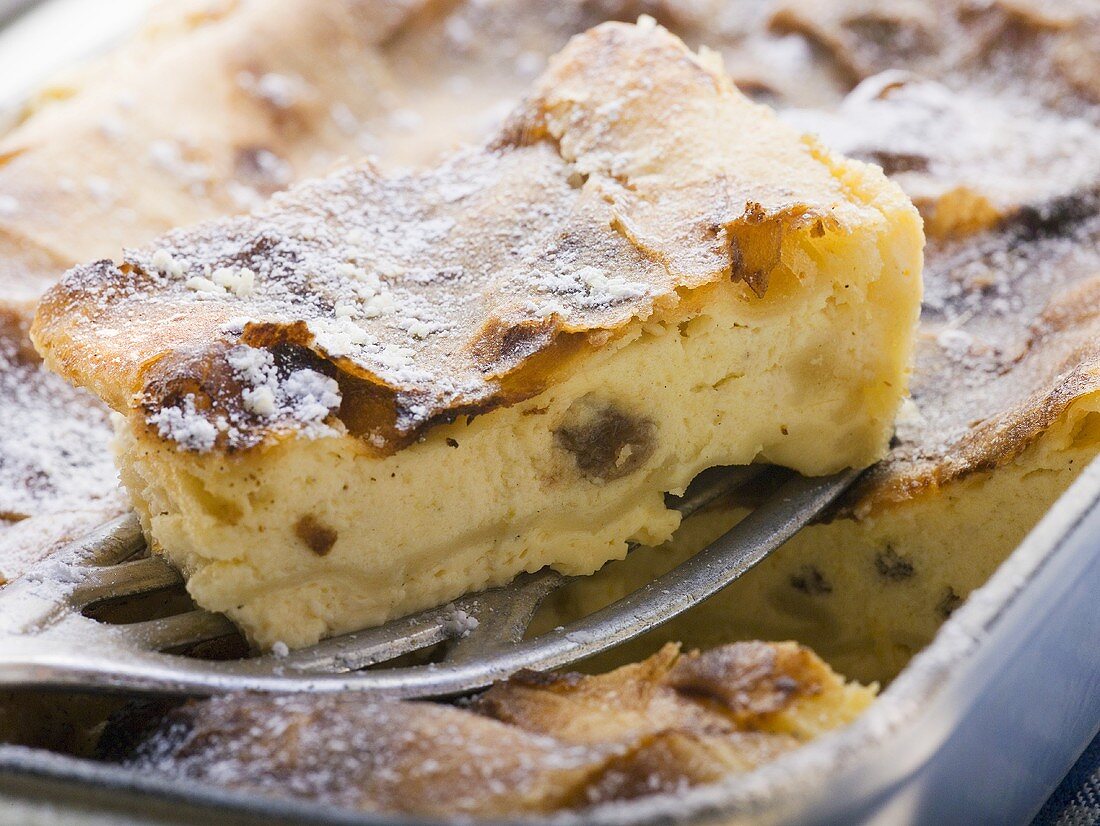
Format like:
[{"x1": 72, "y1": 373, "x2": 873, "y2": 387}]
[{"x1": 553, "y1": 396, "x2": 657, "y2": 482}]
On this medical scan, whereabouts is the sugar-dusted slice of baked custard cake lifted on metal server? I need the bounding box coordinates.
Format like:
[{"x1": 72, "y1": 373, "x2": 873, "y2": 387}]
[{"x1": 34, "y1": 21, "x2": 923, "y2": 646}]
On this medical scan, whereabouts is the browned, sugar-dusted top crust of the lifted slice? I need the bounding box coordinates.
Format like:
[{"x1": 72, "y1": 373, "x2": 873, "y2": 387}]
[{"x1": 35, "y1": 24, "x2": 875, "y2": 449}]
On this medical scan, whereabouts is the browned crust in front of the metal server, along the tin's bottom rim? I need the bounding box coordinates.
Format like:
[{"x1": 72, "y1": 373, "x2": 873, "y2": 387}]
[{"x1": 122, "y1": 642, "x2": 870, "y2": 817}]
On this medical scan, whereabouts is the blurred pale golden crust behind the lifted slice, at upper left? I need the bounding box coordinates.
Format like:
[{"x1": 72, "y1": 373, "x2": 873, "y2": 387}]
[{"x1": 0, "y1": 0, "x2": 721, "y2": 318}]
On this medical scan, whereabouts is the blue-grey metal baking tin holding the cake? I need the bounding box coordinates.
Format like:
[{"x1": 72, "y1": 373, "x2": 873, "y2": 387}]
[{"x1": 0, "y1": 0, "x2": 1100, "y2": 826}]
